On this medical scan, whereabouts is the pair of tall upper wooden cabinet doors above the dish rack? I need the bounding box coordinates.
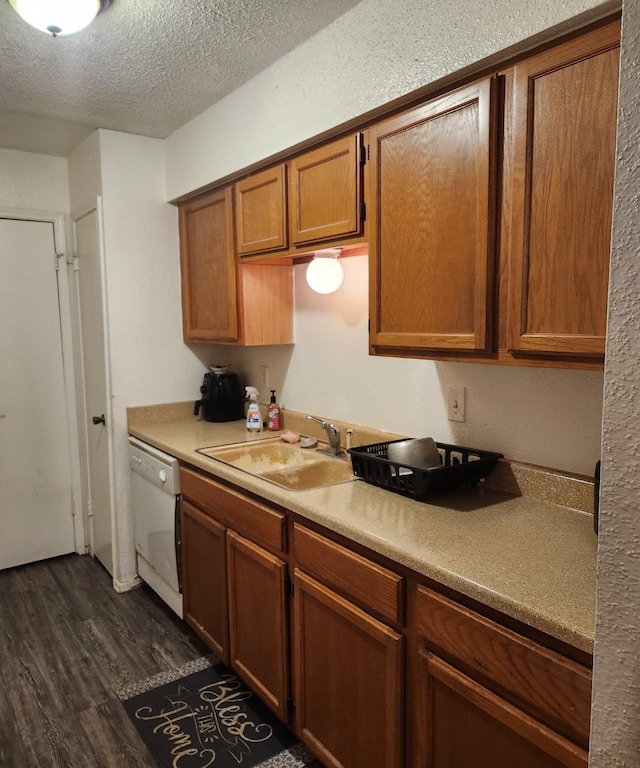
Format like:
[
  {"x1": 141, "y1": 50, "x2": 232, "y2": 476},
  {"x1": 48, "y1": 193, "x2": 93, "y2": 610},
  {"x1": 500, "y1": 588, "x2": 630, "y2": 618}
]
[{"x1": 367, "y1": 22, "x2": 620, "y2": 368}]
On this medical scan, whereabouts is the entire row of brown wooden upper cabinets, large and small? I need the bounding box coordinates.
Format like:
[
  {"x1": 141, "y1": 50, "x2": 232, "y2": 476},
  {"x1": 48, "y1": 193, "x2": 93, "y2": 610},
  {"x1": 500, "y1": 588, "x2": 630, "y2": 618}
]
[{"x1": 180, "y1": 21, "x2": 620, "y2": 369}]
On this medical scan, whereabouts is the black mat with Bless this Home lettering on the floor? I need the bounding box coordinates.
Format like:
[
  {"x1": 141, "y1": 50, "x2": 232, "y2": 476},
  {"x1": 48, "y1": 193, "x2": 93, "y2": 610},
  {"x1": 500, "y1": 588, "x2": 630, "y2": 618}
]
[{"x1": 120, "y1": 663, "x2": 313, "y2": 768}]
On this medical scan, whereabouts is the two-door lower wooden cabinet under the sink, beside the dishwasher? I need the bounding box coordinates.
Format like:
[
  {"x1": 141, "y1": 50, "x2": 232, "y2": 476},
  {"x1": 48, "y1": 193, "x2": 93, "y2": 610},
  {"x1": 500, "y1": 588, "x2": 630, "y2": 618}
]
[{"x1": 180, "y1": 468, "x2": 290, "y2": 722}]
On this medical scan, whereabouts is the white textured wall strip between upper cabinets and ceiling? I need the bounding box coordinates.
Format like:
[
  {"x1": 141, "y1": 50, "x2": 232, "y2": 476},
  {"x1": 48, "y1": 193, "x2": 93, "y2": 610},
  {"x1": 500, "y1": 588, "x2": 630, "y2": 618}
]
[{"x1": 166, "y1": 0, "x2": 611, "y2": 199}]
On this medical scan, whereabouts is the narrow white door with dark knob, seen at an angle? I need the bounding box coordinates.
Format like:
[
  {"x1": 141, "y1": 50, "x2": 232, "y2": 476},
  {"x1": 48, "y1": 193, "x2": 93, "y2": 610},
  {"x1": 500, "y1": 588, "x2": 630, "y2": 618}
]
[{"x1": 74, "y1": 209, "x2": 113, "y2": 575}]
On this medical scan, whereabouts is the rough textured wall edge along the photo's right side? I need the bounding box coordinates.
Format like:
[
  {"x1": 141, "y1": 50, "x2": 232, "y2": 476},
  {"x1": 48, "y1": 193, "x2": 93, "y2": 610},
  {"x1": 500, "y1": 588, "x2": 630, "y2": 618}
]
[{"x1": 589, "y1": 0, "x2": 640, "y2": 768}]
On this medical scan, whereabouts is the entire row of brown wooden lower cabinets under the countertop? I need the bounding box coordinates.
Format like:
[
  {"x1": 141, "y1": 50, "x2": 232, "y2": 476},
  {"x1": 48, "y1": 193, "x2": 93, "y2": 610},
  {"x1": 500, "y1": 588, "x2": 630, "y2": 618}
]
[{"x1": 180, "y1": 467, "x2": 591, "y2": 768}]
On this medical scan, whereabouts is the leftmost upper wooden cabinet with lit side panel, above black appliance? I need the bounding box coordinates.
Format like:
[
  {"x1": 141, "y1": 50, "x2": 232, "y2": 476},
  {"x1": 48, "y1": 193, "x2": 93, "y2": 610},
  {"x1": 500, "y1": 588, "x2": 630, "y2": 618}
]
[{"x1": 179, "y1": 187, "x2": 293, "y2": 346}]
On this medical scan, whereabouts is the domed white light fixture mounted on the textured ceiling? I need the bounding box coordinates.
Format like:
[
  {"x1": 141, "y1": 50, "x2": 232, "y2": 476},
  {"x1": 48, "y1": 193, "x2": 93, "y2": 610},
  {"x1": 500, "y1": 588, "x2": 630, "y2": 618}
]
[{"x1": 9, "y1": 0, "x2": 111, "y2": 37}]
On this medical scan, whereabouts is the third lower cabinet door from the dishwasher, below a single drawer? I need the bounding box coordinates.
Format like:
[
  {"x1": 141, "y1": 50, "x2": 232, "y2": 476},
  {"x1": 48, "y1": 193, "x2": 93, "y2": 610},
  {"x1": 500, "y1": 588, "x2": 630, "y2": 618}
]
[{"x1": 294, "y1": 570, "x2": 403, "y2": 768}]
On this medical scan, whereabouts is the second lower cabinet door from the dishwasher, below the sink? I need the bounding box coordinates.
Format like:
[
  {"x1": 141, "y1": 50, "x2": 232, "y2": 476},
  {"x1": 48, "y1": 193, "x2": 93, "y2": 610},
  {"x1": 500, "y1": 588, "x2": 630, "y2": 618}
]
[{"x1": 227, "y1": 531, "x2": 289, "y2": 722}]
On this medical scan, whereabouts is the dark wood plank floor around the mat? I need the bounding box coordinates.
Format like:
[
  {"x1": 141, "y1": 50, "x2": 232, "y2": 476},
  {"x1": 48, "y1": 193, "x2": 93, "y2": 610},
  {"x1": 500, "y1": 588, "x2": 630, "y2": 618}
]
[{"x1": 0, "y1": 555, "x2": 321, "y2": 768}]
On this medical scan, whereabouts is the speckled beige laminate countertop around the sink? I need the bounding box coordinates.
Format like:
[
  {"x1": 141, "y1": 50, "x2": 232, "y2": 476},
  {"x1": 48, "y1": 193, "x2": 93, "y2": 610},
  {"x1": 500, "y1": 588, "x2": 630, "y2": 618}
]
[{"x1": 129, "y1": 409, "x2": 597, "y2": 653}]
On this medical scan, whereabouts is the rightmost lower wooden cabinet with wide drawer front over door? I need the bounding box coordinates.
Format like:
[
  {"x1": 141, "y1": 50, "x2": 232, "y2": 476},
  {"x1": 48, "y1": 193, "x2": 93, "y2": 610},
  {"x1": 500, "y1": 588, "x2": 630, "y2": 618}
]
[{"x1": 414, "y1": 587, "x2": 591, "y2": 768}]
